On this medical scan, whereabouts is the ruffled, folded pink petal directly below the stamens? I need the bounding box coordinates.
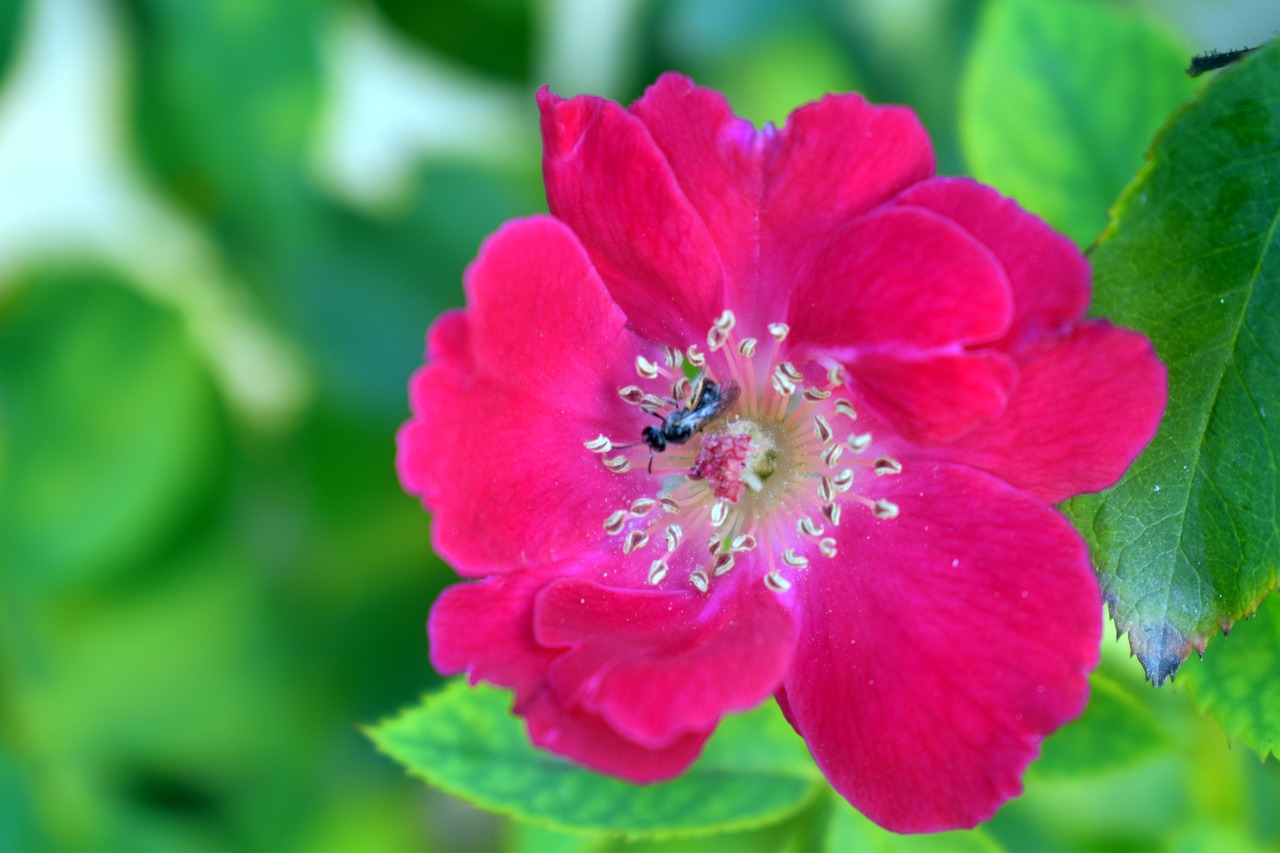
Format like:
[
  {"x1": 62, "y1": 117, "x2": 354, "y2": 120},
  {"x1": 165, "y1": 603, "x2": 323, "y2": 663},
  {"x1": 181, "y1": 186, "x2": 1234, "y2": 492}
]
[{"x1": 534, "y1": 569, "x2": 795, "y2": 747}]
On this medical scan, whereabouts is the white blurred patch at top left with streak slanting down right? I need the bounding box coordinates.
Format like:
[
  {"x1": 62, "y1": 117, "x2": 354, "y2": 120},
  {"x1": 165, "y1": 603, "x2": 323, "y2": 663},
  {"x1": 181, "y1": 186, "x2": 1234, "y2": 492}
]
[{"x1": 0, "y1": 0, "x2": 311, "y2": 428}]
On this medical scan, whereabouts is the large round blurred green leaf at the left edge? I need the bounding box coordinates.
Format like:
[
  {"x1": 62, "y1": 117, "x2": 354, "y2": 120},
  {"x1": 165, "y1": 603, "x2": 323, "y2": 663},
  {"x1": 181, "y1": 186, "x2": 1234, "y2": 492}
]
[{"x1": 0, "y1": 269, "x2": 227, "y2": 588}]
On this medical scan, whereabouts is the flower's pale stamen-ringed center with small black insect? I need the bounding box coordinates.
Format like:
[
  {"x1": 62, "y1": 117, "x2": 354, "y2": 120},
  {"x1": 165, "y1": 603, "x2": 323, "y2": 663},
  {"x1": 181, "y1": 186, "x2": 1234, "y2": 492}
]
[{"x1": 585, "y1": 311, "x2": 902, "y2": 593}]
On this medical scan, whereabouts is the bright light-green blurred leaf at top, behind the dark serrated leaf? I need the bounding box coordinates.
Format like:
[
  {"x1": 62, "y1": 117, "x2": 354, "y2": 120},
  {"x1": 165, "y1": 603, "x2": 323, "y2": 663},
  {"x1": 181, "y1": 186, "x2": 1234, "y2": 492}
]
[{"x1": 960, "y1": 0, "x2": 1194, "y2": 245}]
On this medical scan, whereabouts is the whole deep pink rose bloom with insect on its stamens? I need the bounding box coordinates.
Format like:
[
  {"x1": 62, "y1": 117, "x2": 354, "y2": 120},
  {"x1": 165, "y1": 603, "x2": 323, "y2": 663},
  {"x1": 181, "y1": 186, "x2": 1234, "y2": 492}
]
[{"x1": 398, "y1": 74, "x2": 1166, "y2": 831}]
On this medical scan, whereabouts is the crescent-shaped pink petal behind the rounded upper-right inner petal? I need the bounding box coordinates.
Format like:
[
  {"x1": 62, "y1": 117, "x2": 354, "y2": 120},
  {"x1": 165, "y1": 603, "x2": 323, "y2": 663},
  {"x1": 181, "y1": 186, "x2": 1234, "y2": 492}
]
[{"x1": 895, "y1": 178, "x2": 1089, "y2": 350}]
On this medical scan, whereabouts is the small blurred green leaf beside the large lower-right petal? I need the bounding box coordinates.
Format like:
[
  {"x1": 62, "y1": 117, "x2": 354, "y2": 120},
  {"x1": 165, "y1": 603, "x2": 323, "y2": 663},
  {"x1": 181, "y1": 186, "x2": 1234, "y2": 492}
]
[{"x1": 1030, "y1": 672, "x2": 1170, "y2": 779}]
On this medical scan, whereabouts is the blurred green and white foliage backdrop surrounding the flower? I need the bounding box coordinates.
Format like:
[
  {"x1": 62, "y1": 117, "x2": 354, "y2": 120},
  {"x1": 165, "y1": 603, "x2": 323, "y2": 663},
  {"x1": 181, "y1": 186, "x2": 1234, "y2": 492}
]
[{"x1": 0, "y1": 0, "x2": 1280, "y2": 850}]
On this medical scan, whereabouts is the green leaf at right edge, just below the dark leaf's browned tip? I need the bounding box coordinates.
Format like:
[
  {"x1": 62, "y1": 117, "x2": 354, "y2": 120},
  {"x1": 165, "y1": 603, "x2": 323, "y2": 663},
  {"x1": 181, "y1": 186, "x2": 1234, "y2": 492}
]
[{"x1": 1183, "y1": 598, "x2": 1280, "y2": 756}]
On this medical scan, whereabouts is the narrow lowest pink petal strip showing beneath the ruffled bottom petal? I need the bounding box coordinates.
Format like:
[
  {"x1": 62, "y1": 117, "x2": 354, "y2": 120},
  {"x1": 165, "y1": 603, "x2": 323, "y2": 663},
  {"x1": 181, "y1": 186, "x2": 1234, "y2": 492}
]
[{"x1": 515, "y1": 690, "x2": 710, "y2": 784}]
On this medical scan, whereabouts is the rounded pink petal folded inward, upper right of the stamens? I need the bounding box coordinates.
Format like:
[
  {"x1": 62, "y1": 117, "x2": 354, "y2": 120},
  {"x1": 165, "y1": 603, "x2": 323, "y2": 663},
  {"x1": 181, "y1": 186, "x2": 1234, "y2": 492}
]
[{"x1": 787, "y1": 207, "x2": 1012, "y2": 350}]
